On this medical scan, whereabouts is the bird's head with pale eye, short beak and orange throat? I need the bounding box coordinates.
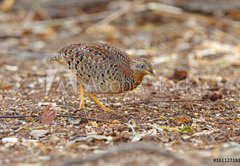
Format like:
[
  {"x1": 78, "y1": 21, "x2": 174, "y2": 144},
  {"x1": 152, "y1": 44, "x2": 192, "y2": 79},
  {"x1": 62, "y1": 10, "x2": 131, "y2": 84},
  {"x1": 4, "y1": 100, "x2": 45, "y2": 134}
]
[{"x1": 131, "y1": 58, "x2": 156, "y2": 82}]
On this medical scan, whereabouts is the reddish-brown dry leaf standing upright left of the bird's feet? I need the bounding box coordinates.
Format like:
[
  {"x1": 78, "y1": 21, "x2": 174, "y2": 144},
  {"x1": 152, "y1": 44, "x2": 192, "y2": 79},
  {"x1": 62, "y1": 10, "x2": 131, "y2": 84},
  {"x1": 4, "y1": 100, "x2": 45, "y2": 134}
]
[{"x1": 41, "y1": 104, "x2": 57, "y2": 125}]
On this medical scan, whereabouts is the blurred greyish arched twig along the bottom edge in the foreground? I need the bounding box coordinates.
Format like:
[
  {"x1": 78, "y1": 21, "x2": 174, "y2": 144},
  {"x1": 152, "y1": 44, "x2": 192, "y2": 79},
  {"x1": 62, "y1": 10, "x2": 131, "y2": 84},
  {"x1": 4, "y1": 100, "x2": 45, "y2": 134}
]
[{"x1": 63, "y1": 142, "x2": 192, "y2": 166}]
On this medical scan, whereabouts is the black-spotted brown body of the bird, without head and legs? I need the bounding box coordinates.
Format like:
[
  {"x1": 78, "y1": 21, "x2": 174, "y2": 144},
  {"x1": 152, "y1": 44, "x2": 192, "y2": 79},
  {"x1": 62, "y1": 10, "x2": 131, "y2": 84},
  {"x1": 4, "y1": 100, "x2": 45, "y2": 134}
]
[{"x1": 54, "y1": 43, "x2": 134, "y2": 93}]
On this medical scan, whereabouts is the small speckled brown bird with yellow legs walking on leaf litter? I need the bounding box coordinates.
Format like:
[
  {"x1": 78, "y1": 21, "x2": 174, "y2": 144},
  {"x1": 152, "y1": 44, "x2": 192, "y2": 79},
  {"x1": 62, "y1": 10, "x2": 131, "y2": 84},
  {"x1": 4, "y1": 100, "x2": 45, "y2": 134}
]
[{"x1": 49, "y1": 42, "x2": 156, "y2": 112}]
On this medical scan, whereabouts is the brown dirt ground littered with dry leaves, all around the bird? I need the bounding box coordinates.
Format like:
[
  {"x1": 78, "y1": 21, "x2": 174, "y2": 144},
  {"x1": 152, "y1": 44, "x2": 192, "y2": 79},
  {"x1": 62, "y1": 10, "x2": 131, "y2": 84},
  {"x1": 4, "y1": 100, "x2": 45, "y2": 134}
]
[{"x1": 0, "y1": 0, "x2": 240, "y2": 166}]
